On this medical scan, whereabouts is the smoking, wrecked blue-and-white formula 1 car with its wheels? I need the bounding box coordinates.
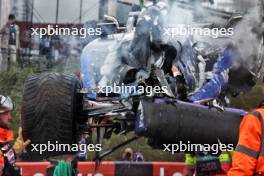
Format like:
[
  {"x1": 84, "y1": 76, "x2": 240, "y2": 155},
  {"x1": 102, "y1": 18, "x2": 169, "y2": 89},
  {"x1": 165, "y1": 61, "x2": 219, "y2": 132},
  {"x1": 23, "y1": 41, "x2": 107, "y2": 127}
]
[{"x1": 22, "y1": 1, "x2": 262, "y2": 160}]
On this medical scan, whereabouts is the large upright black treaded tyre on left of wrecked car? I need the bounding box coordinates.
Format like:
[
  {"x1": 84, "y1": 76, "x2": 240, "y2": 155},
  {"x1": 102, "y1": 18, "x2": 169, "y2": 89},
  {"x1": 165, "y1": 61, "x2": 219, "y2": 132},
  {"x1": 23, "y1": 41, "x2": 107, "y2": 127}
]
[{"x1": 21, "y1": 73, "x2": 81, "y2": 161}]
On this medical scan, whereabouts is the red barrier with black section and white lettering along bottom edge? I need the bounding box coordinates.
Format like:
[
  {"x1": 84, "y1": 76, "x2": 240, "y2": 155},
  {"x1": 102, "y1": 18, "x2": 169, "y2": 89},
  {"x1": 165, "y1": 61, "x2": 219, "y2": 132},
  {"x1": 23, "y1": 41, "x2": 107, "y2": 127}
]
[{"x1": 17, "y1": 161, "x2": 184, "y2": 176}]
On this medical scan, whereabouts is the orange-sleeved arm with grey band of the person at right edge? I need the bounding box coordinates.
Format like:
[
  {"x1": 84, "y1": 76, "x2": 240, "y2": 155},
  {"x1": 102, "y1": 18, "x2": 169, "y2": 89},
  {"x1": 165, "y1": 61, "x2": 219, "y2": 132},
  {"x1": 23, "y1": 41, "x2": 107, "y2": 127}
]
[{"x1": 227, "y1": 114, "x2": 262, "y2": 176}]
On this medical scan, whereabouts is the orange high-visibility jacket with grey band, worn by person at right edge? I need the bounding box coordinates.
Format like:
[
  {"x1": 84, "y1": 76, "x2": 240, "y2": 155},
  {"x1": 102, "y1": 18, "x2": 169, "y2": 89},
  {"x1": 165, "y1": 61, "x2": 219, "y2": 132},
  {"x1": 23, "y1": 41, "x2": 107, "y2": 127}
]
[{"x1": 228, "y1": 108, "x2": 264, "y2": 176}]
